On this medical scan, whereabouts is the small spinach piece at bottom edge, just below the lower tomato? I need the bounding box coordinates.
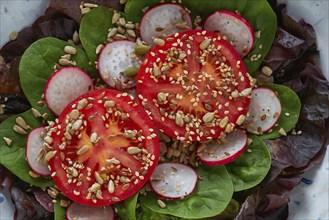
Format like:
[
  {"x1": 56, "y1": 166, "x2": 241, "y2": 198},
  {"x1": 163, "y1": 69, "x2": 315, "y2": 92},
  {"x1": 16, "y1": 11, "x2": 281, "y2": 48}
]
[{"x1": 114, "y1": 193, "x2": 138, "y2": 220}]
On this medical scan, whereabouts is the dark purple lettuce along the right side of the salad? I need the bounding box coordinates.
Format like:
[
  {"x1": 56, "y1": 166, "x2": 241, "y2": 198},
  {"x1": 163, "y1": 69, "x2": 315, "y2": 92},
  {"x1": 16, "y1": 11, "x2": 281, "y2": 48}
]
[{"x1": 236, "y1": 5, "x2": 329, "y2": 220}]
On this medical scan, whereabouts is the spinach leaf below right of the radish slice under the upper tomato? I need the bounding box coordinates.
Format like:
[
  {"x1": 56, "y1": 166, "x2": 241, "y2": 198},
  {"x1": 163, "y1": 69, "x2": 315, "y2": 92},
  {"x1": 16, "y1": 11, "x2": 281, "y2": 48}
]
[{"x1": 225, "y1": 135, "x2": 272, "y2": 192}]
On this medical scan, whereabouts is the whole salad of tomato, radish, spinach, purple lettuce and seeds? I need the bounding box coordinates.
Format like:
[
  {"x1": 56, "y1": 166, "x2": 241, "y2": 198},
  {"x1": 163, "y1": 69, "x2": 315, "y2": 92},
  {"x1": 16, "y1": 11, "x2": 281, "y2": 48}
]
[{"x1": 0, "y1": 0, "x2": 328, "y2": 219}]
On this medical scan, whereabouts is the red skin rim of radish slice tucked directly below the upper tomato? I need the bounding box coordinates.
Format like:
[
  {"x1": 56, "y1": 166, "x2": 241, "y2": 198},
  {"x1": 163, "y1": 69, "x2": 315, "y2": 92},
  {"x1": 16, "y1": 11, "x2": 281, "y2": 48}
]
[{"x1": 199, "y1": 129, "x2": 248, "y2": 166}]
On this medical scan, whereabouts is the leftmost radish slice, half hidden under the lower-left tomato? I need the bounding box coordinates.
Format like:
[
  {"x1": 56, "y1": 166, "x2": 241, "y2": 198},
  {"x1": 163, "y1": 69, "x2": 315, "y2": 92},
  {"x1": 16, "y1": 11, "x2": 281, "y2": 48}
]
[{"x1": 25, "y1": 126, "x2": 50, "y2": 176}]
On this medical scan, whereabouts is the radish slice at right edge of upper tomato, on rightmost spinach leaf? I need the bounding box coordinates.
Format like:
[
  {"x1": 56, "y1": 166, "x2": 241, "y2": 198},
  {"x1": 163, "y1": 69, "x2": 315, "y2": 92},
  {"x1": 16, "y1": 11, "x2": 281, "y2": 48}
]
[{"x1": 243, "y1": 87, "x2": 282, "y2": 134}]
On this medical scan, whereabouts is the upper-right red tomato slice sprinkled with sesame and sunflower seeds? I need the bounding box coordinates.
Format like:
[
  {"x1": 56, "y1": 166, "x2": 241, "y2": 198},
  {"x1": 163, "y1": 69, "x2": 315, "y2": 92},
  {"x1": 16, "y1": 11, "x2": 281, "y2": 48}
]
[{"x1": 137, "y1": 30, "x2": 251, "y2": 142}]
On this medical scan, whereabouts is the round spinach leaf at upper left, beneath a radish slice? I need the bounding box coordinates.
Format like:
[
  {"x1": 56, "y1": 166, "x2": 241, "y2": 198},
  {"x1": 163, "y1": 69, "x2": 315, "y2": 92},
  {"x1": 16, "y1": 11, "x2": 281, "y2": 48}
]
[{"x1": 19, "y1": 37, "x2": 94, "y2": 115}]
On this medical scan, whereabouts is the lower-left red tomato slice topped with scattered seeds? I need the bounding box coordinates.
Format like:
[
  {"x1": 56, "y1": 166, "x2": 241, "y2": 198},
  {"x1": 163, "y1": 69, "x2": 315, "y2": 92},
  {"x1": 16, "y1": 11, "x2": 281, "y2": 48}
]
[{"x1": 46, "y1": 89, "x2": 160, "y2": 206}]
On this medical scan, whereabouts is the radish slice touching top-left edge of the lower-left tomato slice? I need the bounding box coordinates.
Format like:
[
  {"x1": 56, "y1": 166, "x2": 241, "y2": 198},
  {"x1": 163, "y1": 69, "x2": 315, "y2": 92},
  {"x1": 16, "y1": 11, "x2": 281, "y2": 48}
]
[{"x1": 44, "y1": 67, "x2": 94, "y2": 116}]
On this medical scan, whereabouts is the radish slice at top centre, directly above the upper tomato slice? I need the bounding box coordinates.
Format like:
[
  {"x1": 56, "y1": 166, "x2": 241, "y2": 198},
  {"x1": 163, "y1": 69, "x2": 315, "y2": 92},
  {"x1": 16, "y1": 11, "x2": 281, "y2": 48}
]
[{"x1": 140, "y1": 3, "x2": 192, "y2": 45}]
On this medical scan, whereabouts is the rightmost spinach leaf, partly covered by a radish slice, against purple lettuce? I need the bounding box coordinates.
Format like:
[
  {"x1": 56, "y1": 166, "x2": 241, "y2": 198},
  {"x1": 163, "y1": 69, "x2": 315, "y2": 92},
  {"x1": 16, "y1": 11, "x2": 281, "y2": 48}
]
[{"x1": 260, "y1": 83, "x2": 301, "y2": 139}]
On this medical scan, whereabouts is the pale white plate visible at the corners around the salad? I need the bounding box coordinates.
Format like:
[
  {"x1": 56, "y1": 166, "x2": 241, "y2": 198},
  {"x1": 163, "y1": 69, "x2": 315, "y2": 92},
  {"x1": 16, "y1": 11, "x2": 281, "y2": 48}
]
[{"x1": 0, "y1": 0, "x2": 329, "y2": 220}]
